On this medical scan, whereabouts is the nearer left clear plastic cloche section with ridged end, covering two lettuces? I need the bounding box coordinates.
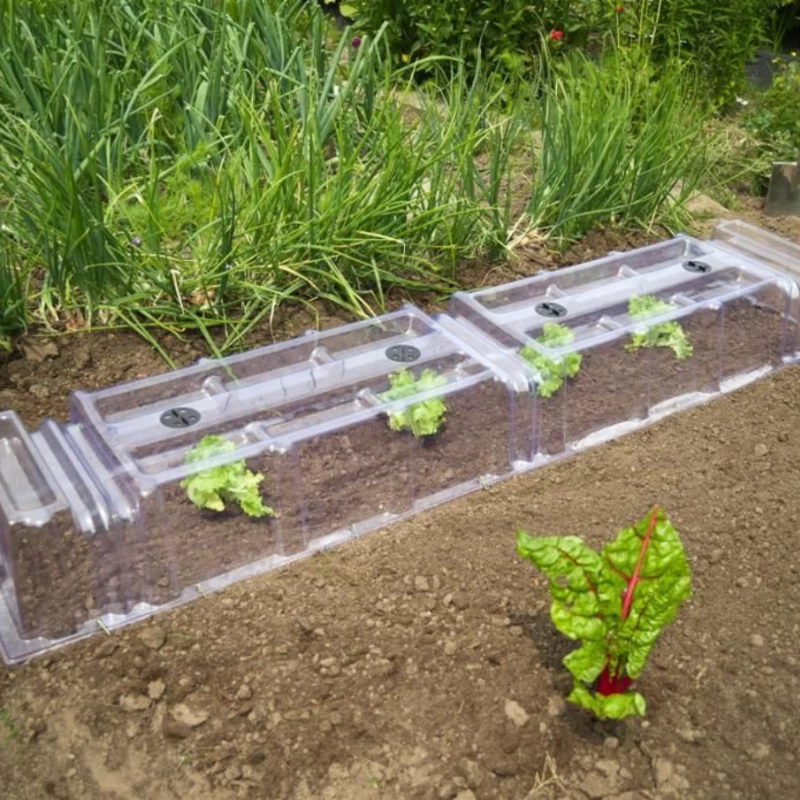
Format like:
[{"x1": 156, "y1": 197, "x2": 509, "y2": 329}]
[{"x1": 0, "y1": 308, "x2": 531, "y2": 659}]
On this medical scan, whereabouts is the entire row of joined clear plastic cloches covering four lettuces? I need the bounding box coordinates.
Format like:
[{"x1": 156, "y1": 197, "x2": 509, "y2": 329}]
[{"x1": 0, "y1": 223, "x2": 800, "y2": 660}]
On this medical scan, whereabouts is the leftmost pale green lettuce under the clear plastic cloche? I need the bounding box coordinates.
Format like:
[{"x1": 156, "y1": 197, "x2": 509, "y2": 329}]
[{"x1": 181, "y1": 436, "x2": 275, "y2": 517}]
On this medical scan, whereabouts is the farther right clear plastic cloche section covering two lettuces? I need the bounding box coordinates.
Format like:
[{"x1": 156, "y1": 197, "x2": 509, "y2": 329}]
[{"x1": 451, "y1": 226, "x2": 800, "y2": 460}]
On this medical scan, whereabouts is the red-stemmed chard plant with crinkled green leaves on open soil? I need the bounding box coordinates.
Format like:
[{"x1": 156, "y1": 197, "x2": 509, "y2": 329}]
[{"x1": 517, "y1": 506, "x2": 692, "y2": 719}]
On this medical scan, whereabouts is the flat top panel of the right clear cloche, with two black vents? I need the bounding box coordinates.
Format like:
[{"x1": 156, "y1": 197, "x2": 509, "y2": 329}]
[{"x1": 452, "y1": 231, "x2": 796, "y2": 358}]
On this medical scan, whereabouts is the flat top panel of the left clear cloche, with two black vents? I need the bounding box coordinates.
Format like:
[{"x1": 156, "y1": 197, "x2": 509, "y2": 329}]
[{"x1": 72, "y1": 307, "x2": 524, "y2": 488}]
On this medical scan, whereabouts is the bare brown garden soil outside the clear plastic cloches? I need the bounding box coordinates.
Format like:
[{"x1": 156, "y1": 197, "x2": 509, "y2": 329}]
[{"x1": 0, "y1": 208, "x2": 800, "y2": 800}]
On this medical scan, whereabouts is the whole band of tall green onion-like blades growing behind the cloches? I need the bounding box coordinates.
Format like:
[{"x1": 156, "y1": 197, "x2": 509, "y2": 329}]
[{"x1": 0, "y1": 0, "x2": 720, "y2": 357}]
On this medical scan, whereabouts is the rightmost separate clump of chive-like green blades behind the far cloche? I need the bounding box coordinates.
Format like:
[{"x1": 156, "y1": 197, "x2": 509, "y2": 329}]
[{"x1": 529, "y1": 50, "x2": 713, "y2": 241}]
